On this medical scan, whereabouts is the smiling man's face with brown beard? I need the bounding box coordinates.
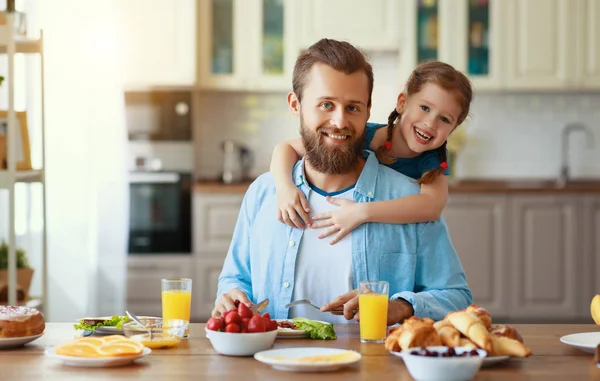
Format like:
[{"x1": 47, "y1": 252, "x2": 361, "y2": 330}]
[{"x1": 288, "y1": 63, "x2": 370, "y2": 175}]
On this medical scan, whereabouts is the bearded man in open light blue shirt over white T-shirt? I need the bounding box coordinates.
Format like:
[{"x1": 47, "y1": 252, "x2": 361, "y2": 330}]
[{"x1": 213, "y1": 39, "x2": 472, "y2": 325}]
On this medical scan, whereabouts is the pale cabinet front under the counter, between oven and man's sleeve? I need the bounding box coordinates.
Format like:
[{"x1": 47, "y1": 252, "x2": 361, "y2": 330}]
[{"x1": 192, "y1": 192, "x2": 244, "y2": 252}]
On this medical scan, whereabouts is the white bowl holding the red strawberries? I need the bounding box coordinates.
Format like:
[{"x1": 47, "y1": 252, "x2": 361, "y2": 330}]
[{"x1": 204, "y1": 328, "x2": 277, "y2": 356}]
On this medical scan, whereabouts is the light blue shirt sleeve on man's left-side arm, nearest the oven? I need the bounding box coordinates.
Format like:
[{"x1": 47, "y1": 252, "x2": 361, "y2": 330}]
[{"x1": 217, "y1": 186, "x2": 255, "y2": 300}]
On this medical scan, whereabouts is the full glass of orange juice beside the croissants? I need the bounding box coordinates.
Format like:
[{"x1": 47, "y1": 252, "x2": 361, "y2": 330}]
[{"x1": 358, "y1": 280, "x2": 390, "y2": 343}]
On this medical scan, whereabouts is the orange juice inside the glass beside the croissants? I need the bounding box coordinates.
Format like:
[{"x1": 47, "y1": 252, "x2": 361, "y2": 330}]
[{"x1": 358, "y1": 293, "x2": 388, "y2": 341}]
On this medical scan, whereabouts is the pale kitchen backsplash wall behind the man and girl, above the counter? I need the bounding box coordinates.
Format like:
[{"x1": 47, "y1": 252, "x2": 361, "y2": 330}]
[{"x1": 194, "y1": 91, "x2": 600, "y2": 179}]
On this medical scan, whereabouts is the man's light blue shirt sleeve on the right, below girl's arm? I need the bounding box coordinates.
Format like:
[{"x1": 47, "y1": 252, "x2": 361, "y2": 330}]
[{"x1": 390, "y1": 218, "x2": 473, "y2": 321}]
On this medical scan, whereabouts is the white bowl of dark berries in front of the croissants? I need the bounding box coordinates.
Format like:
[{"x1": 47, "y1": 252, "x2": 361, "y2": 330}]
[{"x1": 402, "y1": 346, "x2": 487, "y2": 381}]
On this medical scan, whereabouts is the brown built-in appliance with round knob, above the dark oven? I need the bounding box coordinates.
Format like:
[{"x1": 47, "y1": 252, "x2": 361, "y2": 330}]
[{"x1": 125, "y1": 90, "x2": 192, "y2": 141}]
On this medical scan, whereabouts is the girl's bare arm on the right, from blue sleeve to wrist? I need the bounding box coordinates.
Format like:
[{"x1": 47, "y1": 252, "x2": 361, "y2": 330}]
[{"x1": 362, "y1": 175, "x2": 448, "y2": 224}]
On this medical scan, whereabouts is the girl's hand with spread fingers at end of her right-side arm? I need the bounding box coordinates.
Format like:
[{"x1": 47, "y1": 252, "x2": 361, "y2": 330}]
[{"x1": 311, "y1": 197, "x2": 366, "y2": 245}]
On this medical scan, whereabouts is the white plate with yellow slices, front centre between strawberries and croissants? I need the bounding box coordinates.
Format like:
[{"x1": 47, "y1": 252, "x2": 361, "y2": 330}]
[{"x1": 254, "y1": 348, "x2": 362, "y2": 372}]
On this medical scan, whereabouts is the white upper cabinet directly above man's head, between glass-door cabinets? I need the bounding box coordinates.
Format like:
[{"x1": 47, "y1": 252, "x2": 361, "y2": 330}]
[{"x1": 299, "y1": 0, "x2": 407, "y2": 50}]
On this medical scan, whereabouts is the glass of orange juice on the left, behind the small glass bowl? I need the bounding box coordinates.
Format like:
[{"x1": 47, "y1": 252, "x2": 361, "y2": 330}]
[{"x1": 160, "y1": 278, "x2": 192, "y2": 338}]
